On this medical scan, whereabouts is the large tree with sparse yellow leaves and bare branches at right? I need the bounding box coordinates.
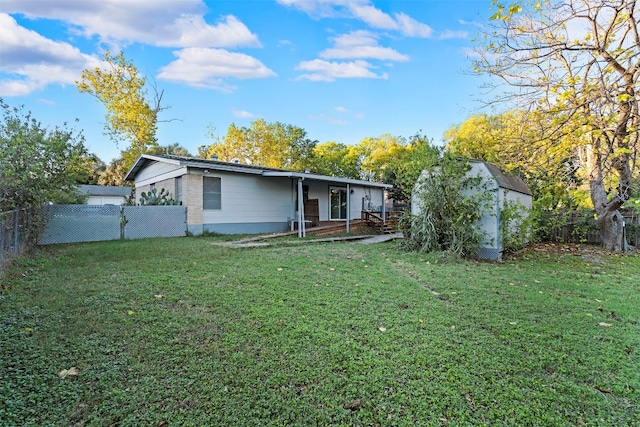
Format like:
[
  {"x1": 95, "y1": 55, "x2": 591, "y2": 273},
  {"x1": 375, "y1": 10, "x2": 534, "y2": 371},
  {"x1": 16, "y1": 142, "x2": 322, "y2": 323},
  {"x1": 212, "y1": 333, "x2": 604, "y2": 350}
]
[{"x1": 475, "y1": 0, "x2": 640, "y2": 251}]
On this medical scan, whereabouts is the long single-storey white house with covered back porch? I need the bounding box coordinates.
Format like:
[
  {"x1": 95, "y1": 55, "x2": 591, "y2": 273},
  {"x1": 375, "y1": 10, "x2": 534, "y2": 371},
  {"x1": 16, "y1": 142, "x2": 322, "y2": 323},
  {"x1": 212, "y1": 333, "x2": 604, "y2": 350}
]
[{"x1": 125, "y1": 154, "x2": 392, "y2": 236}]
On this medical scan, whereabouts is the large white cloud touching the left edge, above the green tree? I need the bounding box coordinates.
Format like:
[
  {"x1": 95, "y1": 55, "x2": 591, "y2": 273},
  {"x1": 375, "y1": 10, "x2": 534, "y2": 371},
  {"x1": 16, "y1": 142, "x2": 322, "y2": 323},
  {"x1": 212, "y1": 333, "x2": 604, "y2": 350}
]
[{"x1": 0, "y1": 13, "x2": 101, "y2": 96}]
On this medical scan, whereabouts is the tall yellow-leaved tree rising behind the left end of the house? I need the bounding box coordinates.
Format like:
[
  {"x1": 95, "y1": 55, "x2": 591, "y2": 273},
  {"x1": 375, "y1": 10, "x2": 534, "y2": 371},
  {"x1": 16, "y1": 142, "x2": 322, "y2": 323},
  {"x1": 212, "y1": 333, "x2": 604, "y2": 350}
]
[{"x1": 76, "y1": 51, "x2": 166, "y2": 175}]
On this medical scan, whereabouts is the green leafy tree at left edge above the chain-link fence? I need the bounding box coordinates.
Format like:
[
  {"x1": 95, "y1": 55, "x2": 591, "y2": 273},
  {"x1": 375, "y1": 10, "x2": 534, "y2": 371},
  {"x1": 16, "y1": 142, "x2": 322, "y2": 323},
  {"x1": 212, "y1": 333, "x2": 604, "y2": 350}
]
[{"x1": 0, "y1": 99, "x2": 87, "y2": 214}]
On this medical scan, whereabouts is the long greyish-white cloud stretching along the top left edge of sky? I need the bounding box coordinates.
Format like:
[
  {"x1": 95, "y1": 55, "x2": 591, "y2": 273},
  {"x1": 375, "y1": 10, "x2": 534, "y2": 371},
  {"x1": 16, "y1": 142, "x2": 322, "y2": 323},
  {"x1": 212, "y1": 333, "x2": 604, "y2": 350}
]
[{"x1": 0, "y1": 0, "x2": 260, "y2": 48}]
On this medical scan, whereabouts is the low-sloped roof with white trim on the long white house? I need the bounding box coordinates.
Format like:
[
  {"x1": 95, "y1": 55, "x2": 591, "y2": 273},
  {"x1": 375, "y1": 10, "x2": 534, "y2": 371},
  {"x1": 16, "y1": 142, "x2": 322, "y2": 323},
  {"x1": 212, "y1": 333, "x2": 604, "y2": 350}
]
[{"x1": 124, "y1": 154, "x2": 393, "y2": 188}]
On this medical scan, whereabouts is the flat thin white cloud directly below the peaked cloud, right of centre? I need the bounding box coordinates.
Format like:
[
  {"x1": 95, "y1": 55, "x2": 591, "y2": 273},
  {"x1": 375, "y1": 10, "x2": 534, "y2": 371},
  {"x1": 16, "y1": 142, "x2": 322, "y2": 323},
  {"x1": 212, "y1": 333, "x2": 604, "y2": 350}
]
[{"x1": 296, "y1": 59, "x2": 388, "y2": 82}]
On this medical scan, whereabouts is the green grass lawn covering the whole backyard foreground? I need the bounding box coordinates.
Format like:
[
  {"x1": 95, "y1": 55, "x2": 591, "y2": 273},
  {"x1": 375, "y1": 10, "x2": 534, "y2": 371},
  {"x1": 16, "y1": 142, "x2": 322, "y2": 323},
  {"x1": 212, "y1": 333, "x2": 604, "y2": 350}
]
[{"x1": 0, "y1": 237, "x2": 640, "y2": 426}]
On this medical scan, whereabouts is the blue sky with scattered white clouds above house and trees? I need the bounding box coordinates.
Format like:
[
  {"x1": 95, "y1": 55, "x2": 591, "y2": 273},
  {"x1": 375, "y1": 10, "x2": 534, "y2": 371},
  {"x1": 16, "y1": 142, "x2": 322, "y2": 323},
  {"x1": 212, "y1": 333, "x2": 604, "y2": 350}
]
[{"x1": 0, "y1": 0, "x2": 491, "y2": 162}]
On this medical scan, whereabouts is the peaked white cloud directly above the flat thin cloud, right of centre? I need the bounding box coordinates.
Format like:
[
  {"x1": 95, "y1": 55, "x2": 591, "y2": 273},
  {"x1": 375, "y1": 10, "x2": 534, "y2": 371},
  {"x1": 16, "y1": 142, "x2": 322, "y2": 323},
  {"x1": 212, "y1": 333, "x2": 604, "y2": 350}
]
[{"x1": 320, "y1": 31, "x2": 409, "y2": 61}]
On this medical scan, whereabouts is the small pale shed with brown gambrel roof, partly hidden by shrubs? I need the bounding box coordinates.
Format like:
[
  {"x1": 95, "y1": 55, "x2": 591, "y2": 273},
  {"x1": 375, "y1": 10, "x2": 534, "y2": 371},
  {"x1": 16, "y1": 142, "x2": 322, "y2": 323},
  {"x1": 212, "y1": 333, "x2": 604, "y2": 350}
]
[{"x1": 411, "y1": 160, "x2": 533, "y2": 260}]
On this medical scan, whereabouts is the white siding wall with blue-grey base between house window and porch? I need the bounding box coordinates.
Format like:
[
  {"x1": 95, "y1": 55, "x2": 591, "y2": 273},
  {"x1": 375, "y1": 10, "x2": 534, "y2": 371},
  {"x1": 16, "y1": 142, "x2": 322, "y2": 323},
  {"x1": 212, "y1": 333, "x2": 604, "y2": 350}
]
[{"x1": 200, "y1": 171, "x2": 295, "y2": 234}]
